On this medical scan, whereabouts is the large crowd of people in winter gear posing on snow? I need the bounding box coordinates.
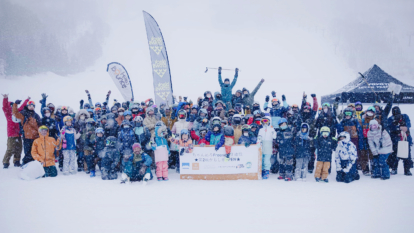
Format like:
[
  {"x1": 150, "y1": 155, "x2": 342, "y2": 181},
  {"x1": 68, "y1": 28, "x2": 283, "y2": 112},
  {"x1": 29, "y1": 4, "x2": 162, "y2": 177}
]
[{"x1": 3, "y1": 68, "x2": 413, "y2": 183}]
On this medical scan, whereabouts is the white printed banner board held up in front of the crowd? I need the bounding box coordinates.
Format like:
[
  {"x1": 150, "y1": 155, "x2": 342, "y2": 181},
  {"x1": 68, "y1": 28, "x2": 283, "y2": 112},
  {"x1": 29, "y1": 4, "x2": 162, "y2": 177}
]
[{"x1": 180, "y1": 145, "x2": 262, "y2": 180}]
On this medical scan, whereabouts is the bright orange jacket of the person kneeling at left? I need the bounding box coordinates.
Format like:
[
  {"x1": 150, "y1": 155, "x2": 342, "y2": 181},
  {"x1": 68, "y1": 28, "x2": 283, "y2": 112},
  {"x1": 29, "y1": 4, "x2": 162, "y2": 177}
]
[{"x1": 32, "y1": 129, "x2": 62, "y2": 167}]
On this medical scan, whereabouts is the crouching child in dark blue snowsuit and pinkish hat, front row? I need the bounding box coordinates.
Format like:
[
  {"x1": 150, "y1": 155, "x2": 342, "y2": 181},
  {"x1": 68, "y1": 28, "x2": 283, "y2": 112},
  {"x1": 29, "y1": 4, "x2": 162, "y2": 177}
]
[{"x1": 121, "y1": 143, "x2": 152, "y2": 184}]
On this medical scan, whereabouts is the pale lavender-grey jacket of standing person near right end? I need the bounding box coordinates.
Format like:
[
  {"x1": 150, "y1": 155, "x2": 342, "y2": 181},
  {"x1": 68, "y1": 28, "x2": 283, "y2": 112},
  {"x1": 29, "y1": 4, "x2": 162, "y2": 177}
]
[{"x1": 368, "y1": 121, "x2": 393, "y2": 155}]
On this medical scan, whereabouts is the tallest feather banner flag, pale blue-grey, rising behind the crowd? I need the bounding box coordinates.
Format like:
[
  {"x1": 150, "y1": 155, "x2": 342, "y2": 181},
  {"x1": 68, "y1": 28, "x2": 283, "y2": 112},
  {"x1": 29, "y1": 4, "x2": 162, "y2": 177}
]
[{"x1": 143, "y1": 11, "x2": 173, "y2": 106}]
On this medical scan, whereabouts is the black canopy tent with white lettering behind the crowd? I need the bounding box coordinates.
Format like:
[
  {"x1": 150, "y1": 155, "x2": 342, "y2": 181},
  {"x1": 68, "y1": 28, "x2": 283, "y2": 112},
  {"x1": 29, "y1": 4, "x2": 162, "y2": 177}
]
[{"x1": 322, "y1": 65, "x2": 414, "y2": 104}]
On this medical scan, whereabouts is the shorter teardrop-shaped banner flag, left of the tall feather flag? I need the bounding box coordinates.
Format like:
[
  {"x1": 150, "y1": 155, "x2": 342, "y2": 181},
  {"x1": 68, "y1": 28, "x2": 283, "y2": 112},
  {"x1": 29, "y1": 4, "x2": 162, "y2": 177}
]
[{"x1": 106, "y1": 62, "x2": 134, "y2": 101}]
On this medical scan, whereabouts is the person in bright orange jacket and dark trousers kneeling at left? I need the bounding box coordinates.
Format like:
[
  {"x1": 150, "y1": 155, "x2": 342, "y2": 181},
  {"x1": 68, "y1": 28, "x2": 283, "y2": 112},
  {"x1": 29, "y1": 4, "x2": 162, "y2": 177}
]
[{"x1": 31, "y1": 125, "x2": 61, "y2": 177}]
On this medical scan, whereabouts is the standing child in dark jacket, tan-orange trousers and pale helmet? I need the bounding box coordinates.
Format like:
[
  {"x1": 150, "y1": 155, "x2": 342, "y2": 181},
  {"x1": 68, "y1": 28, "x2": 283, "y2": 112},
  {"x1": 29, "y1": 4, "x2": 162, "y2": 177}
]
[{"x1": 315, "y1": 126, "x2": 337, "y2": 183}]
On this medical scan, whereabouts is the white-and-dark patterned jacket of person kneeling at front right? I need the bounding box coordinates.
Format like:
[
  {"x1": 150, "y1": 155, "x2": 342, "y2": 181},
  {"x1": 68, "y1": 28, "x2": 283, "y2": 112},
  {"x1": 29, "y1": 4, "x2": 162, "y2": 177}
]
[{"x1": 334, "y1": 133, "x2": 358, "y2": 171}]
